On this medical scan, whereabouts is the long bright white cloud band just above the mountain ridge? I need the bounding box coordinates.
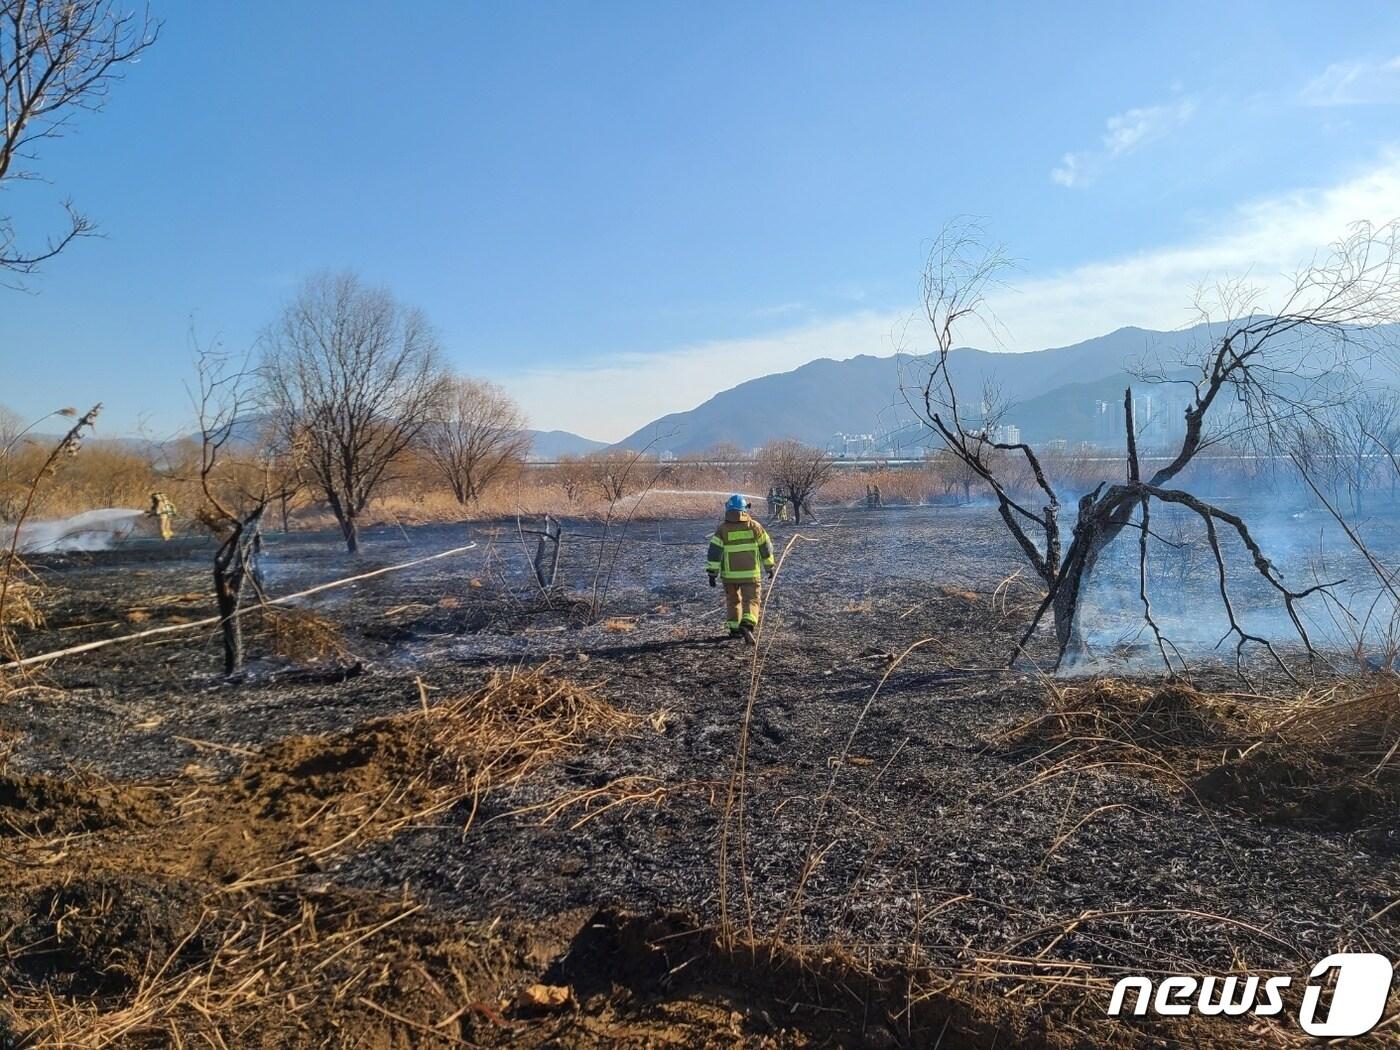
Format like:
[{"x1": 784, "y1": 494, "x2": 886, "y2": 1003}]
[{"x1": 497, "y1": 153, "x2": 1400, "y2": 440}]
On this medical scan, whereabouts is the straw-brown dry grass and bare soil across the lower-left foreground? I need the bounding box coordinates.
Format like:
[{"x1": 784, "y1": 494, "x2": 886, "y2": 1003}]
[{"x1": 0, "y1": 672, "x2": 1170, "y2": 1050}]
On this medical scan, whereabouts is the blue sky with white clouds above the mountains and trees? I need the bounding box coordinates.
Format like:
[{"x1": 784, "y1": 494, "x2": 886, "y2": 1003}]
[{"x1": 0, "y1": 0, "x2": 1400, "y2": 438}]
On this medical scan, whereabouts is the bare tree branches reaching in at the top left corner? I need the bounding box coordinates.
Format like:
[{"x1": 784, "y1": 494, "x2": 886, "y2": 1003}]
[{"x1": 0, "y1": 0, "x2": 160, "y2": 276}]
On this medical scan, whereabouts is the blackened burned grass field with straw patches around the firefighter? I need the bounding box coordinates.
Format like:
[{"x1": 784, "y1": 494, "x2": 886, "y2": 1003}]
[{"x1": 0, "y1": 508, "x2": 1400, "y2": 1047}]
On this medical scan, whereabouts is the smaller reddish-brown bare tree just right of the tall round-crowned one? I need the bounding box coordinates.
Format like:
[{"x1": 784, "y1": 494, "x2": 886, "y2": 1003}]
[{"x1": 423, "y1": 377, "x2": 531, "y2": 507}]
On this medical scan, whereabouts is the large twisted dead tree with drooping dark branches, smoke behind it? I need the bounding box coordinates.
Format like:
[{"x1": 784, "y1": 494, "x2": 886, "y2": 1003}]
[{"x1": 904, "y1": 224, "x2": 1400, "y2": 671}]
